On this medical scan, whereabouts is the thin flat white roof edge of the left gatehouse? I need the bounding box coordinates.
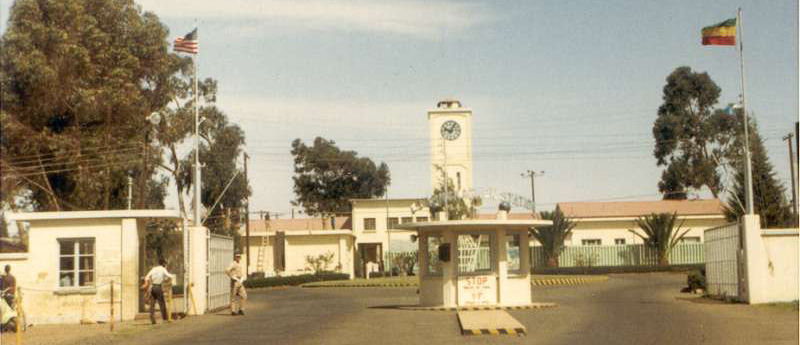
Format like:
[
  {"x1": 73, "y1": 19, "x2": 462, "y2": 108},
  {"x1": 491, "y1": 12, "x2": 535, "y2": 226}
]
[{"x1": 5, "y1": 210, "x2": 181, "y2": 221}]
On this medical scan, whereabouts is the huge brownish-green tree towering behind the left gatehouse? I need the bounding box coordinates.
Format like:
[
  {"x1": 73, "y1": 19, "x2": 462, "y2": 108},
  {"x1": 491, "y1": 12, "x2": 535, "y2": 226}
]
[{"x1": 0, "y1": 0, "x2": 180, "y2": 210}]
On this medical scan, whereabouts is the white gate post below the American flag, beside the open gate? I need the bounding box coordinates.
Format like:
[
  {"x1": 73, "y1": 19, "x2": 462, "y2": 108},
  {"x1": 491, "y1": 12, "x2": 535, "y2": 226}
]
[{"x1": 187, "y1": 226, "x2": 209, "y2": 315}]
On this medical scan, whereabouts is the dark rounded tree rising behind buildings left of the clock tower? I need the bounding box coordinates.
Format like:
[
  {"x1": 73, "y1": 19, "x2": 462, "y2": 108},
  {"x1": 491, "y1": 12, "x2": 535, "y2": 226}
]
[{"x1": 291, "y1": 137, "x2": 391, "y2": 217}]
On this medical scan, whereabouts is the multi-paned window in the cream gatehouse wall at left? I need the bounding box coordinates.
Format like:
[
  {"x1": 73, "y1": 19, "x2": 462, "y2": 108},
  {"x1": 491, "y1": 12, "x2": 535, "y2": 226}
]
[{"x1": 58, "y1": 238, "x2": 94, "y2": 287}]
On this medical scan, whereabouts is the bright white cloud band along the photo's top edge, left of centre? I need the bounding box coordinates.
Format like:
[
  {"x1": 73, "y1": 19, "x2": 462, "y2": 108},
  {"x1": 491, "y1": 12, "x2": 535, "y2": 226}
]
[{"x1": 137, "y1": 0, "x2": 493, "y2": 37}]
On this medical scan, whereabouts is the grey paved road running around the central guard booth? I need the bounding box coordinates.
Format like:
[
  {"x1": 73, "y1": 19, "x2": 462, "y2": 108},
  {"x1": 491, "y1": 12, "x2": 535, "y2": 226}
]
[{"x1": 15, "y1": 273, "x2": 798, "y2": 345}]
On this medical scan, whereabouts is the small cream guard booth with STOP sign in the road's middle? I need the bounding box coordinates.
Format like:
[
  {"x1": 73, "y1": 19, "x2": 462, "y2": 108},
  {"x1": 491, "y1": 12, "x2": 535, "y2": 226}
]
[{"x1": 399, "y1": 211, "x2": 552, "y2": 307}]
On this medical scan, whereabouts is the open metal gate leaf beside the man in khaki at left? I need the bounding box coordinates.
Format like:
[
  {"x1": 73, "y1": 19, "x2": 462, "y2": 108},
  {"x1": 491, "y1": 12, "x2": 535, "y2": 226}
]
[{"x1": 207, "y1": 234, "x2": 233, "y2": 311}]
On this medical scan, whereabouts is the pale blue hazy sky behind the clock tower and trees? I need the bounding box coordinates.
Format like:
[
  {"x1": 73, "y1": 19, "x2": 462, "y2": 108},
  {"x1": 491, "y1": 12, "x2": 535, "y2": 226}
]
[{"x1": 0, "y1": 0, "x2": 798, "y2": 214}]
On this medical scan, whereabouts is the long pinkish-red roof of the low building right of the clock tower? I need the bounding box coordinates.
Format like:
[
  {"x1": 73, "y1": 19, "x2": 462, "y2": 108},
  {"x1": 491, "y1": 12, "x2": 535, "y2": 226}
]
[{"x1": 557, "y1": 199, "x2": 724, "y2": 218}]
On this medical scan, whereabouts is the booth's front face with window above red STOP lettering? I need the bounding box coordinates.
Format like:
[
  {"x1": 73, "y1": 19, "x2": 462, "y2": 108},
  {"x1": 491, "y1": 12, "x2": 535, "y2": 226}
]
[{"x1": 456, "y1": 232, "x2": 497, "y2": 306}]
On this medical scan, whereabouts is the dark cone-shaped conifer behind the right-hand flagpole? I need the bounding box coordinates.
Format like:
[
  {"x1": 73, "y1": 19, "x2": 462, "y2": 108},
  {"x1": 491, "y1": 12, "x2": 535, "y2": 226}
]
[{"x1": 725, "y1": 110, "x2": 793, "y2": 228}]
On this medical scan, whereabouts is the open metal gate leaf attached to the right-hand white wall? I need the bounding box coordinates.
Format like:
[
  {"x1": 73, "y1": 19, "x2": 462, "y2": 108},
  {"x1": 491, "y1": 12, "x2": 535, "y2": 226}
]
[{"x1": 704, "y1": 223, "x2": 742, "y2": 298}]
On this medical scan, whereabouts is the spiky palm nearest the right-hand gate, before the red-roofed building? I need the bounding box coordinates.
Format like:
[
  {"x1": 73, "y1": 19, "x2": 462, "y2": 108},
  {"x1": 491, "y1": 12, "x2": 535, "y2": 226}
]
[{"x1": 628, "y1": 213, "x2": 691, "y2": 266}]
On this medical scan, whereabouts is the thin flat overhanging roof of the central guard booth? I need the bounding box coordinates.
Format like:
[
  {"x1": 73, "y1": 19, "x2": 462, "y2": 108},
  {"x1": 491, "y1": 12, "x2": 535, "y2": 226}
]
[{"x1": 397, "y1": 219, "x2": 553, "y2": 232}]
